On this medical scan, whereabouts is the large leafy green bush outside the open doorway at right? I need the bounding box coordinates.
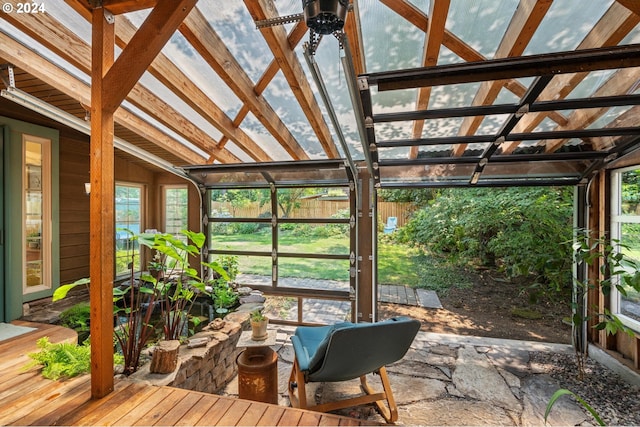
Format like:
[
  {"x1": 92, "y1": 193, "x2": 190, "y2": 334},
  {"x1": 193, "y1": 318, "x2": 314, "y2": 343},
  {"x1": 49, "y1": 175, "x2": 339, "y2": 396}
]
[{"x1": 398, "y1": 187, "x2": 573, "y2": 290}]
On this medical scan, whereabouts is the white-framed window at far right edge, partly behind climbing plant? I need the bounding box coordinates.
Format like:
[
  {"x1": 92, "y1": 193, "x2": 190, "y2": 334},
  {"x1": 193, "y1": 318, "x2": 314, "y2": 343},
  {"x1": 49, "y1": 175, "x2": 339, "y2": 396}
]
[{"x1": 611, "y1": 166, "x2": 640, "y2": 331}]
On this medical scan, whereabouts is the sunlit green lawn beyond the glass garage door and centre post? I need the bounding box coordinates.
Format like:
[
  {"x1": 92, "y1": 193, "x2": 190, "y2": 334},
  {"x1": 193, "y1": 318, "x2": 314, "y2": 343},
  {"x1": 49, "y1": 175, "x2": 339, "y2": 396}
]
[{"x1": 212, "y1": 231, "x2": 471, "y2": 291}]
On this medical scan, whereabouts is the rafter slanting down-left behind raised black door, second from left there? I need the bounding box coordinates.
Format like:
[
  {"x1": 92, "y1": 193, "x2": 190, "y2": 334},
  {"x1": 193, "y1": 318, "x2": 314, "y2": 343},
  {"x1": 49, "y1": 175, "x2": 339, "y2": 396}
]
[{"x1": 453, "y1": 0, "x2": 552, "y2": 156}]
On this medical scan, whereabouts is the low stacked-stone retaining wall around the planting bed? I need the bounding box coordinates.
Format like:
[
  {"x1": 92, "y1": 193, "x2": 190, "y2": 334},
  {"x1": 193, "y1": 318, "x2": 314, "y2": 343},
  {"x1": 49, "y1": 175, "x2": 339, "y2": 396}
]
[{"x1": 129, "y1": 316, "x2": 248, "y2": 393}]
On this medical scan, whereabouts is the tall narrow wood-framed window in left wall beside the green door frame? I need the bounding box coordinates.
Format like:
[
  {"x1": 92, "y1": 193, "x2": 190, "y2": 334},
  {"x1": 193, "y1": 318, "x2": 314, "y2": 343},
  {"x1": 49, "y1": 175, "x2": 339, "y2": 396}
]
[{"x1": 22, "y1": 135, "x2": 52, "y2": 294}]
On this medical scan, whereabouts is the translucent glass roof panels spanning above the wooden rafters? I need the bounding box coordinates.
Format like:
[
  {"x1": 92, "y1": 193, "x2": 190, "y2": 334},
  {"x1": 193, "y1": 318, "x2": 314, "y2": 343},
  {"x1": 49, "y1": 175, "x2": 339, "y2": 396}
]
[{"x1": 0, "y1": 0, "x2": 640, "y2": 187}]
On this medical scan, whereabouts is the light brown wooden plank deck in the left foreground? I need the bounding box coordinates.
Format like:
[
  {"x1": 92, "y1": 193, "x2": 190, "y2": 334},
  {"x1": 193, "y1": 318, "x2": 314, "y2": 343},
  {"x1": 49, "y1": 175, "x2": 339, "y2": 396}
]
[{"x1": 0, "y1": 322, "x2": 362, "y2": 426}]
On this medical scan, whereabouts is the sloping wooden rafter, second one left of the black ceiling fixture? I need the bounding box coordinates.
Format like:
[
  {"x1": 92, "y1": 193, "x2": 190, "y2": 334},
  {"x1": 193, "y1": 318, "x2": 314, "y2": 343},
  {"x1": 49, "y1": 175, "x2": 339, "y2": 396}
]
[{"x1": 180, "y1": 9, "x2": 309, "y2": 160}]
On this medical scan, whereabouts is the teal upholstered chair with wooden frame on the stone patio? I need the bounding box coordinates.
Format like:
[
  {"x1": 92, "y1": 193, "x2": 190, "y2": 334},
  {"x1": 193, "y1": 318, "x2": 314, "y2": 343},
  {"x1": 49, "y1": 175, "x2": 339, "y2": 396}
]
[{"x1": 288, "y1": 317, "x2": 420, "y2": 423}]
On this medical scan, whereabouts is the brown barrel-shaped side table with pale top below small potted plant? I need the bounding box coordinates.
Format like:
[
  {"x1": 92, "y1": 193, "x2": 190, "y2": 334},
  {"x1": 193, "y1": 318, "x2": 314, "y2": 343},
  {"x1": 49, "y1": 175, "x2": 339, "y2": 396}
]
[{"x1": 236, "y1": 330, "x2": 278, "y2": 404}]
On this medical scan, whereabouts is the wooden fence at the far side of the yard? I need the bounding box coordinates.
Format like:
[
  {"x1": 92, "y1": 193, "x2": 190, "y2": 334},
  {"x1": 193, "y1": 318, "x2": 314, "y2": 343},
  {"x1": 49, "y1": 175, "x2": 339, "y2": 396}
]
[{"x1": 211, "y1": 199, "x2": 413, "y2": 227}]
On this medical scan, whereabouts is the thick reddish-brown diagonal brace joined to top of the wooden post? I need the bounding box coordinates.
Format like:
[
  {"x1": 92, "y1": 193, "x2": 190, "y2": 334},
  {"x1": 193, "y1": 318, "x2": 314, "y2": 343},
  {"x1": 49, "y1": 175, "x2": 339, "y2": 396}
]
[{"x1": 103, "y1": 0, "x2": 198, "y2": 115}]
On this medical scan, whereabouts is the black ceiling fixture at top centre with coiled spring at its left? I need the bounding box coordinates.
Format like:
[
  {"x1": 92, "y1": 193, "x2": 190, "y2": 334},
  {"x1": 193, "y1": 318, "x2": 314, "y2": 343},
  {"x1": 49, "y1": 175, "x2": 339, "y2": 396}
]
[{"x1": 256, "y1": 0, "x2": 351, "y2": 54}]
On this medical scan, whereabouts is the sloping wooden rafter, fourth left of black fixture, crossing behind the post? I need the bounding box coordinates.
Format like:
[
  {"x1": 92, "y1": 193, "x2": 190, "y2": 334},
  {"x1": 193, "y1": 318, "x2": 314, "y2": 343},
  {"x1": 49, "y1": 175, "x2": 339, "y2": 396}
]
[{"x1": 7, "y1": 10, "x2": 240, "y2": 163}]
